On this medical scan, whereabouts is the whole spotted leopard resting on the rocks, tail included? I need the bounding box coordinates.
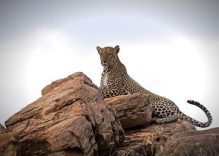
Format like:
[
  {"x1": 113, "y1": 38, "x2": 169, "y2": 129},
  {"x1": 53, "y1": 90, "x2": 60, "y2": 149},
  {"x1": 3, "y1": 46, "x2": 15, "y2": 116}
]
[{"x1": 96, "y1": 45, "x2": 212, "y2": 128}]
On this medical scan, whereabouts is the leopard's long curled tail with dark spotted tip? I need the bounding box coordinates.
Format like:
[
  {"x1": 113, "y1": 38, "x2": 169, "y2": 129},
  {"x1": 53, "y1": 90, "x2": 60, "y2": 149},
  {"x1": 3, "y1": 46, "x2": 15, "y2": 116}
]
[{"x1": 182, "y1": 100, "x2": 212, "y2": 128}]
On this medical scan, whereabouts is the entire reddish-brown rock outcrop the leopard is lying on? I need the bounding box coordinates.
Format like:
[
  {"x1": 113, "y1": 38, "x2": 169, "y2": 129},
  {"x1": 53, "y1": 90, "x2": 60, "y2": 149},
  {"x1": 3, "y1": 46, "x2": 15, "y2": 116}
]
[{"x1": 0, "y1": 73, "x2": 219, "y2": 156}]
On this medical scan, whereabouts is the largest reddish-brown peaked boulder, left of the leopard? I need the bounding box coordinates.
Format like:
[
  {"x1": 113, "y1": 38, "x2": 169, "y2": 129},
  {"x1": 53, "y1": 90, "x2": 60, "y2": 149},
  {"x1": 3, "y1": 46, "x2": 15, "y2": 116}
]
[{"x1": 0, "y1": 73, "x2": 124, "y2": 156}]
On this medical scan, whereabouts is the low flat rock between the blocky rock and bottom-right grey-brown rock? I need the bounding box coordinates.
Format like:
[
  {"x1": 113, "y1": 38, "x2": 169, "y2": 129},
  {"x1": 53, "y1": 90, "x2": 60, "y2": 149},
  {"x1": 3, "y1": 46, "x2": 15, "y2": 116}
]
[{"x1": 111, "y1": 121, "x2": 195, "y2": 156}]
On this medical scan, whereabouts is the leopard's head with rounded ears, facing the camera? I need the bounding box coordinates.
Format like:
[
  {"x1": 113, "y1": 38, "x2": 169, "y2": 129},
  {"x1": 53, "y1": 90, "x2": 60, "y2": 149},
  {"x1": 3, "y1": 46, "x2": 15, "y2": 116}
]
[{"x1": 97, "y1": 45, "x2": 119, "y2": 69}]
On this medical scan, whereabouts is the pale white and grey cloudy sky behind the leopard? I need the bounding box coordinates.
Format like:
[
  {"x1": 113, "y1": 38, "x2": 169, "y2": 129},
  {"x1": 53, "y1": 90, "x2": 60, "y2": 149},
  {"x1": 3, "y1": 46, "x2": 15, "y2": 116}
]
[{"x1": 0, "y1": 0, "x2": 219, "y2": 127}]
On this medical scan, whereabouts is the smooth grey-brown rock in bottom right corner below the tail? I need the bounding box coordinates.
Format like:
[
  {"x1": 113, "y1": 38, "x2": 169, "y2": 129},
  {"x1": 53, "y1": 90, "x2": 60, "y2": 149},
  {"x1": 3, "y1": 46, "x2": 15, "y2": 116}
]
[{"x1": 156, "y1": 128, "x2": 219, "y2": 156}]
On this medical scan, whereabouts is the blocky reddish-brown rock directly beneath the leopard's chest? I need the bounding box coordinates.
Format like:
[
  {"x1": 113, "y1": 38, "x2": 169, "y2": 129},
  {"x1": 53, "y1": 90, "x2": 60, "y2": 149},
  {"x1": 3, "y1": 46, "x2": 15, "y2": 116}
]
[{"x1": 105, "y1": 93, "x2": 152, "y2": 129}]
